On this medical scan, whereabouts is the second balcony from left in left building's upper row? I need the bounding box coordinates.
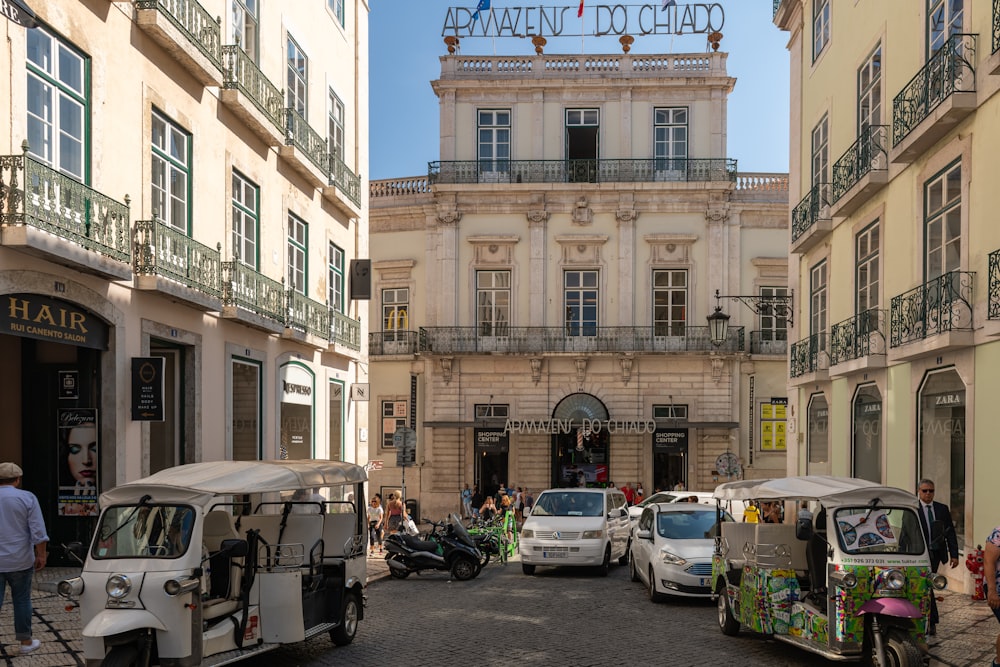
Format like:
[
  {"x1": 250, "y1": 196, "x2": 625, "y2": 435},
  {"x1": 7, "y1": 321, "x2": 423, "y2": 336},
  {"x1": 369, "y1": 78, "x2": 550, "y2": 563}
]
[{"x1": 219, "y1": 45, "x2": 286, "y2": 146}]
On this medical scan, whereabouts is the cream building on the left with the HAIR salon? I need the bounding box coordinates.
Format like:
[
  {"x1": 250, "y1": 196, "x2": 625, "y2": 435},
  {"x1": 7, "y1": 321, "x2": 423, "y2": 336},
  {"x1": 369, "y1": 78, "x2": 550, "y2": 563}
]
[{"x1": 0, "y1": 0, "x2": 369, "y2": 542}]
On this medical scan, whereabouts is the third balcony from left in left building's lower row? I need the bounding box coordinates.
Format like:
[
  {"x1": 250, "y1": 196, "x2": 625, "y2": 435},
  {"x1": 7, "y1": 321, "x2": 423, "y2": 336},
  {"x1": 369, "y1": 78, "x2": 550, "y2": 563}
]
[{"x1": 222, "y1": 260, "x2": 286, "y2": 333}]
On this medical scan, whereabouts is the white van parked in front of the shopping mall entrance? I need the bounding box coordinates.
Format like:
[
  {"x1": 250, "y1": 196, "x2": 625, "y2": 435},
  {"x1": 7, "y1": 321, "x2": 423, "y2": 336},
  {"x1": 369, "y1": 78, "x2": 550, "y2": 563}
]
[{"x1": 518, "y1": 488, "x2": 629, "y2": 575}]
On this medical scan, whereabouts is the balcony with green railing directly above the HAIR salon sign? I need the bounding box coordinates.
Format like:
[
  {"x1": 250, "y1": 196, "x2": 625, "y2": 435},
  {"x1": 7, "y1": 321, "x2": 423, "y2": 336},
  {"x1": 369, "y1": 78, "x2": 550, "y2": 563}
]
[{"x1": 0, "y1": 149, "x2": 132, "y2": 280}]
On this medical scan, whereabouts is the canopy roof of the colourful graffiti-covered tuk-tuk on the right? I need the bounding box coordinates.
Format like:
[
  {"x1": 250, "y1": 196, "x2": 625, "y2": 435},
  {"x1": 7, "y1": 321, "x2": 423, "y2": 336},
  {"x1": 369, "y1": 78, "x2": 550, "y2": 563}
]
[{"x1": 713, "y1": 475, "x2": 917, "y2": 507}]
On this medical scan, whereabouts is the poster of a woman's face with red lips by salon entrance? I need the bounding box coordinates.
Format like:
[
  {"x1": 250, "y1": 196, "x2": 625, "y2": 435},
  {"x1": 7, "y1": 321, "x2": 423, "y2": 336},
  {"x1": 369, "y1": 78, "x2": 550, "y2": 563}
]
[{"x1": 56, "y1": 408, "x2": 100, "y2": 516}]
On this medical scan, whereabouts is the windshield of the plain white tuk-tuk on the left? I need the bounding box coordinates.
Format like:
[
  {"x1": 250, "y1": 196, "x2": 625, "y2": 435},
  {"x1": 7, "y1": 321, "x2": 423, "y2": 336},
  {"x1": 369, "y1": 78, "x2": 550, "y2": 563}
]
[{"x1": 91, "y1": 504, "x2": 194, "y2": 560}]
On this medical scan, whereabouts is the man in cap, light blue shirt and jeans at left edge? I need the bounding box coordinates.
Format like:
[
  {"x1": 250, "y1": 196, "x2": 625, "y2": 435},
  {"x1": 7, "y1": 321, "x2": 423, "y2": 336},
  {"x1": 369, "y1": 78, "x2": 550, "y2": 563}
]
[{"x1": 0, "y1": 462, "x2": 49, "y2": 655}]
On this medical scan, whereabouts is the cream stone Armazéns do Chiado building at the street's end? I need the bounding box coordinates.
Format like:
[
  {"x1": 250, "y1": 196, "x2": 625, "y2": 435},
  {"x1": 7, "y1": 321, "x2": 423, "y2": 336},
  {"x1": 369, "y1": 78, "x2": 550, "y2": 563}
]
[{"x1": 369, "y1": 45, "x2": 788, "y2": 518}]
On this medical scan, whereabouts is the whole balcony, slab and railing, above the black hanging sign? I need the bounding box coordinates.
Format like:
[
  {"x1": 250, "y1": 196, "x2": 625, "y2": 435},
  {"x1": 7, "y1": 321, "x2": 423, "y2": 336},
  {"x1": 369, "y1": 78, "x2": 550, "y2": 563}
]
[{"x1": 135, "y1": 220, "x2": 222, "y2": 311}]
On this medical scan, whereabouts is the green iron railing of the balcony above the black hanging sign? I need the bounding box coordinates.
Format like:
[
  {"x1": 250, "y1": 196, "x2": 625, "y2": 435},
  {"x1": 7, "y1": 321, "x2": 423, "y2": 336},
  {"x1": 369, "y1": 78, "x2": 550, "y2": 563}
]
[{"x1": 135, "y1": 220, "x2": 222, "y2": 297}]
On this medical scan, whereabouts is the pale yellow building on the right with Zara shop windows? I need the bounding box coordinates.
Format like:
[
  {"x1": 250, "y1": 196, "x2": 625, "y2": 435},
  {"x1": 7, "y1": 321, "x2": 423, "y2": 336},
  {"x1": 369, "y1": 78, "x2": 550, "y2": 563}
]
[{"x1": 774, "y1": 0, "x2": 1000, "y2": 583}]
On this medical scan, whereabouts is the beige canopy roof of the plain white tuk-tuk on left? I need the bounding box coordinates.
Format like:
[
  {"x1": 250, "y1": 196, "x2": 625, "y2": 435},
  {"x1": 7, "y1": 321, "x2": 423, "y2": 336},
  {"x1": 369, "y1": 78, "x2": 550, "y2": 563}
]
[{"x1": 100, "y1": 459, "x2": 368, "y2": 507}]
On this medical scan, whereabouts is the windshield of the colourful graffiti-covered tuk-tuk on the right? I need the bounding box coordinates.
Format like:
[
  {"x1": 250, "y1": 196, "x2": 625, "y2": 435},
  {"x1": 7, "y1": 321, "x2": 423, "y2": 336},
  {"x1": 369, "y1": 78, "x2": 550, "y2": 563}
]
[{"x1": 834, "y1": 507, "x2": 924, "y2": 556}]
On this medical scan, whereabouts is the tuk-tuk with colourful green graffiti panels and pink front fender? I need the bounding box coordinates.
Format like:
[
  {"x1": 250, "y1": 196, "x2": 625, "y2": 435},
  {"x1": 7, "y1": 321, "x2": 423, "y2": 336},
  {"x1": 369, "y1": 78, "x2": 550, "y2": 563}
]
[{"x1": 712, "y1": 475, "x2": 947, "y2": 667}]
